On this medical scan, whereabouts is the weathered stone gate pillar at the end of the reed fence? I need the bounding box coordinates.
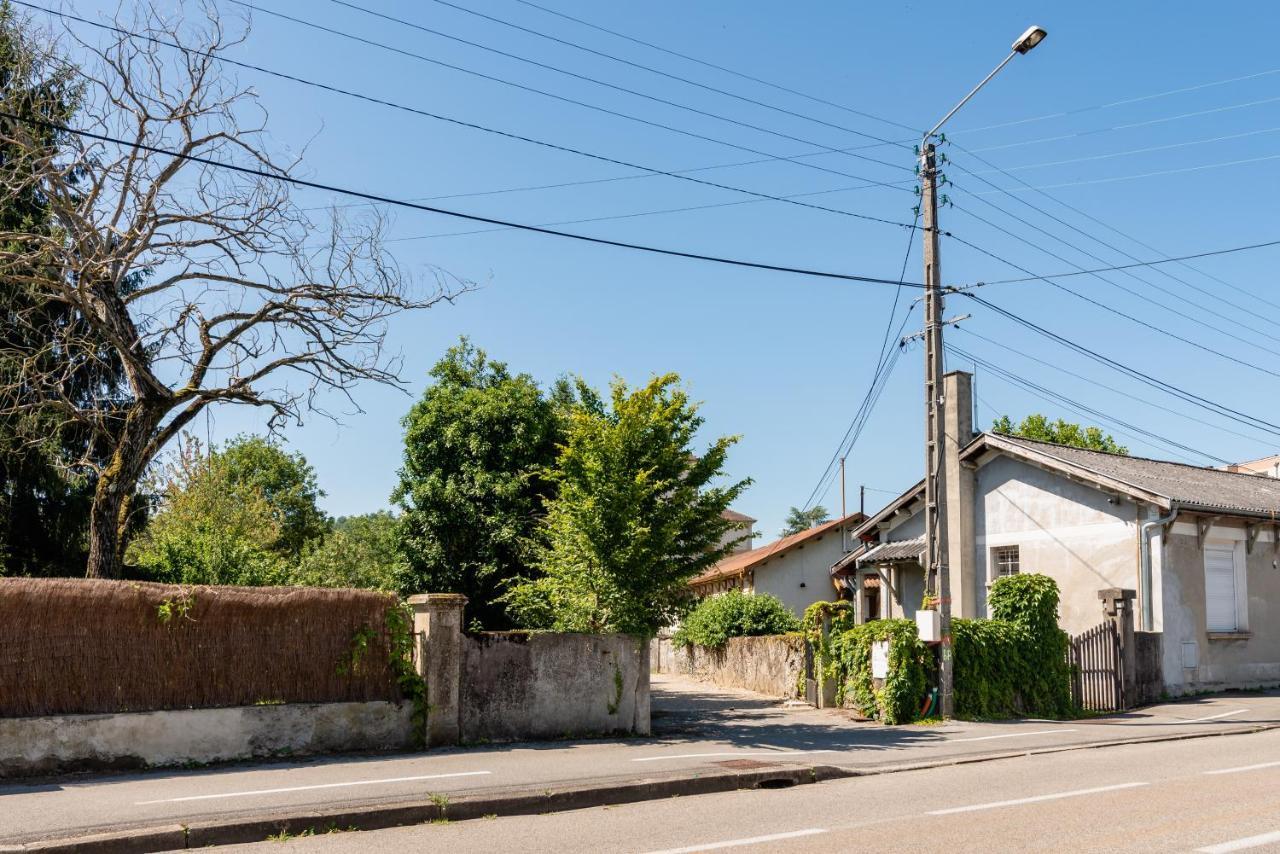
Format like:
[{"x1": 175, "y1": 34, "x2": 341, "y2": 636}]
[{"x1": 408, "y1": 593, "x2": 467, "y2": 748}]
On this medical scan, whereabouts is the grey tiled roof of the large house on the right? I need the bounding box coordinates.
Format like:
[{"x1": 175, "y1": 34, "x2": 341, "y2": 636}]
[{"x1": 993, "y1": 434, "x2": 1280, "y2": 517}]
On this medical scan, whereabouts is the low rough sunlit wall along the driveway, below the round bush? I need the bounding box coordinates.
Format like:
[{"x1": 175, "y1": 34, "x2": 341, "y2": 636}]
[{"x1": 650, "y1": 635, "x2": 804, "y2": 699}]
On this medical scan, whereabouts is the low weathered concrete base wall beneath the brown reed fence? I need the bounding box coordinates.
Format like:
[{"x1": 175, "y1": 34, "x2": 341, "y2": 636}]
[{"x1": 0, "y1": 702, "x2": 415, "y2": 777}]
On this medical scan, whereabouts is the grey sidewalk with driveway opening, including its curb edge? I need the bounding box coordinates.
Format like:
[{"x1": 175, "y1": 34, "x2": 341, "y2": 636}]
[{"x1": 0, "y1": 675, "x2": 1280, "y2": 851}]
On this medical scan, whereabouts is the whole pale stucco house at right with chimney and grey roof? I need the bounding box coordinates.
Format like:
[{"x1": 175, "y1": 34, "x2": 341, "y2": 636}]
[{"x1": 832, "y1": 371, "x2": 1280, "y2": 694}]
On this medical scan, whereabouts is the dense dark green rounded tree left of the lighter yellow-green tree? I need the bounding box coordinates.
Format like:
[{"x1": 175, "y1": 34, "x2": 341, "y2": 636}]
[{"x1": 392, "y1": 338, "x2": 563, "y2": 629}]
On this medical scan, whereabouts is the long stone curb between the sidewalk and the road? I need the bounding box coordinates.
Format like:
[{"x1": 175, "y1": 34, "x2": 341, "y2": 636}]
[{"x1": 12, "y1": 723, "x2": 1280, "y2": 854}]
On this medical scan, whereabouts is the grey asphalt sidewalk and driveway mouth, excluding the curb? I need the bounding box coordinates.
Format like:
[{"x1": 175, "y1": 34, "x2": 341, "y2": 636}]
[{"x1": 0, "y1": 676, "x2": 1280, "y2": 844}]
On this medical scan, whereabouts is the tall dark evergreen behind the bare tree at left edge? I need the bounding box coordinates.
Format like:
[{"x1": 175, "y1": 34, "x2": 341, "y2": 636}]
[{"x1": 0, "y1": 3, "x2": 136, "y2": 575}]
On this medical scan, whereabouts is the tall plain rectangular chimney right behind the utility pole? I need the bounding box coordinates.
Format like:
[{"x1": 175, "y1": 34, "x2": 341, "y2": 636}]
[{"x1": 941, "y1": 371, "x2": 987, "y2": 617}]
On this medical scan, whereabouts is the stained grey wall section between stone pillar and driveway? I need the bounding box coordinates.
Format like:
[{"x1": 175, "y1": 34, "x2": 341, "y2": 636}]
[{"x1": 460, "y1": 631, "x2": 649, "y2": 743}]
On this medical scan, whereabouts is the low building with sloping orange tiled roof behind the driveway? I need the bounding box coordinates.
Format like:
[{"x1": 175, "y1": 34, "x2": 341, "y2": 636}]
[{"x1": 690, "y1": 513, "x2": 865, "y2": 617}]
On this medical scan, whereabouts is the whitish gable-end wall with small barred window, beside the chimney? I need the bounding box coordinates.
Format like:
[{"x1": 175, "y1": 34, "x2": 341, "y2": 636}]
[{"x1": 963, "y1": 457, "x2": 1140, "y2": 634}]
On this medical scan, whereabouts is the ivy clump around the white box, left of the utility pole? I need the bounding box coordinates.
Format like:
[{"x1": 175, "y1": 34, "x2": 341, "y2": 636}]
[{"x1": 831, "y1": 620, "x2": 933, "y2": 723}]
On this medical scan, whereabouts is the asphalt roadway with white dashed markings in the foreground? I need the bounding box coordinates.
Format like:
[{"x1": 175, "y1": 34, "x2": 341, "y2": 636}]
[{"x1": 222, "y1": 731, "x2": 1280, "y2": 854}]
